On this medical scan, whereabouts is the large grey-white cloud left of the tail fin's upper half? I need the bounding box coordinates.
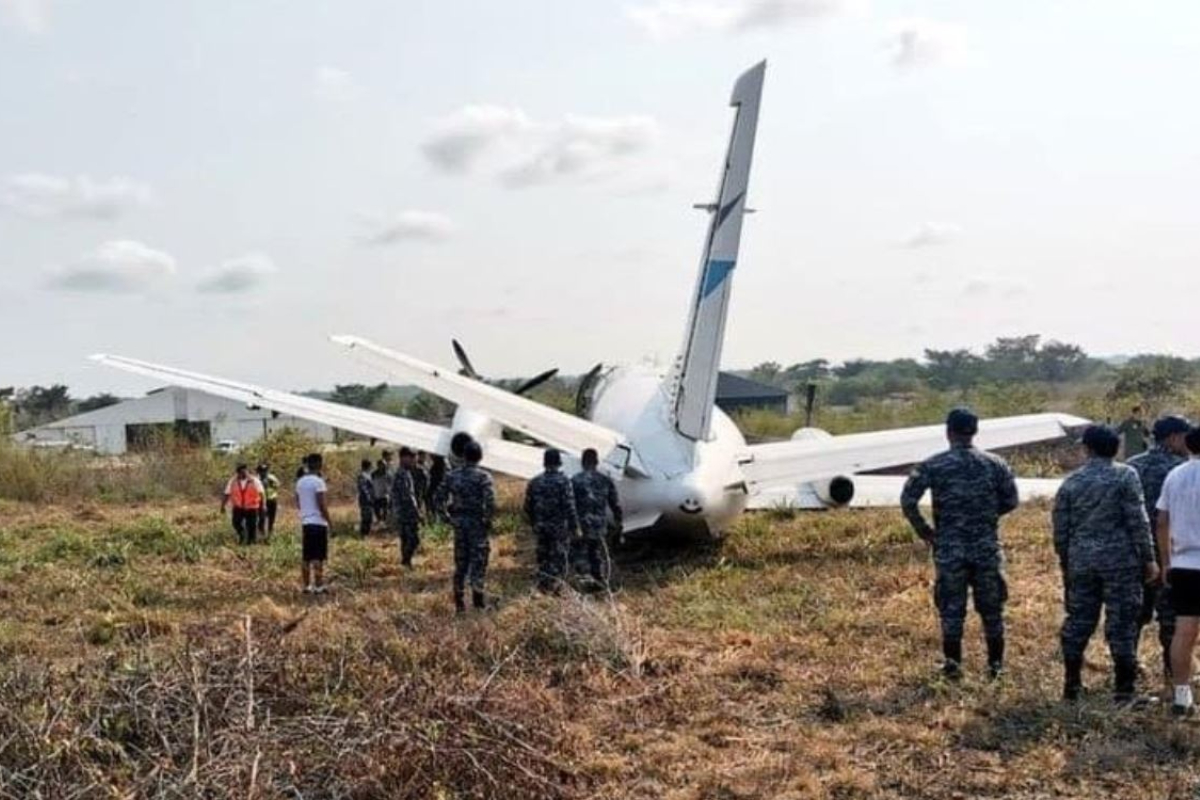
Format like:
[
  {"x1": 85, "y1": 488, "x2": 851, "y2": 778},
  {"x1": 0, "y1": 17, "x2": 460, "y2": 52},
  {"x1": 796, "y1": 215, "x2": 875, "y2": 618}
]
[{"x1": 421, "y1": 106, "x2": 659, "y2": 187}]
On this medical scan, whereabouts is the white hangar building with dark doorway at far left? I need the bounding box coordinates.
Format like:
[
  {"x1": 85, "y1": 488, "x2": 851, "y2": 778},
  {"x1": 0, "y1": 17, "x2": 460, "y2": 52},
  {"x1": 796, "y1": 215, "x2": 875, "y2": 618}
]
[{"x1": 13, "y1": 386, "x2": 334, "y2": 456}]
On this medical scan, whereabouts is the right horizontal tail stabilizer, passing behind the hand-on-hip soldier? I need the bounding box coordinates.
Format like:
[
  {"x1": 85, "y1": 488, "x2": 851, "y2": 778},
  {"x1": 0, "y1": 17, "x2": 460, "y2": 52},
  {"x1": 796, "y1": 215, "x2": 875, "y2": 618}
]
[{"x1": 743, "y1": 414, "x2": 1088, "y2": 494}]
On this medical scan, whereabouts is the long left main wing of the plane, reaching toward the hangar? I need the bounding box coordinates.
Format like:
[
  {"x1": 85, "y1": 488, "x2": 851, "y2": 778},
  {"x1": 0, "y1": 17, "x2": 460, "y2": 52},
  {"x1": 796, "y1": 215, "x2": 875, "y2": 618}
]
[{"x1": 91, "y1": 355, "x2": 541, "y2": 479}]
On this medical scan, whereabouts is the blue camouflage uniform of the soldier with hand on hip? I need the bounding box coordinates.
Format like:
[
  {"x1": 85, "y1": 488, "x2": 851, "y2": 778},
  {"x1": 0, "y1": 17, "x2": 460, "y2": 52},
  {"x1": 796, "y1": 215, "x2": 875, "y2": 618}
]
[{"x1": 900, "y1": 444, "x2": 1018, "y2": 648}]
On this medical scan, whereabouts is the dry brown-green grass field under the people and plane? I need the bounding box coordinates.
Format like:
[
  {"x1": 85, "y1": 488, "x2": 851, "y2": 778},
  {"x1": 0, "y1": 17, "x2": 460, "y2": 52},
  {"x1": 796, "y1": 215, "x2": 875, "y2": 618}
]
[{"x1": 0, "y1": 484, "x2": 1200, "y2": 800}]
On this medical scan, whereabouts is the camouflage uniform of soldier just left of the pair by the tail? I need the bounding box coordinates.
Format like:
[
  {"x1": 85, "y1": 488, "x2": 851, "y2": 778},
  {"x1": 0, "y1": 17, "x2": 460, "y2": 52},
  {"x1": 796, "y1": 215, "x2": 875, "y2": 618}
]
[{"x1": 436, "y1": 464, "x2": 496, "y2": 604}]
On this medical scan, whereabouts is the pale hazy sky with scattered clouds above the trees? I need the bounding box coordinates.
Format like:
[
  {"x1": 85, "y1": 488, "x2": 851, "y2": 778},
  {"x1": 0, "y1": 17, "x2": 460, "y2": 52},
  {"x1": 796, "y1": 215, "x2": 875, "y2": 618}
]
[{"x1": 0, "y1": 0, "x2": 1200, "y2": 396}]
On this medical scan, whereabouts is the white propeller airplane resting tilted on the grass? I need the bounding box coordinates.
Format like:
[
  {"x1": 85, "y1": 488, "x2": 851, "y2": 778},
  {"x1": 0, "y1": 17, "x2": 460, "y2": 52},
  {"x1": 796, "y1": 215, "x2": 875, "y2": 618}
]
[{"x1": 92, "y1": 61, "x2": 1087, "y2": 535}]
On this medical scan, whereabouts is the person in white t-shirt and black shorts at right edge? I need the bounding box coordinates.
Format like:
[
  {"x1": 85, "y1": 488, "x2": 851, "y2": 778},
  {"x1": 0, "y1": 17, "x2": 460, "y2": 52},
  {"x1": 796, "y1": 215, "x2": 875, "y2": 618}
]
[{"x1": 1156, "y1": 427, "x2": 1200, "y2": 716}]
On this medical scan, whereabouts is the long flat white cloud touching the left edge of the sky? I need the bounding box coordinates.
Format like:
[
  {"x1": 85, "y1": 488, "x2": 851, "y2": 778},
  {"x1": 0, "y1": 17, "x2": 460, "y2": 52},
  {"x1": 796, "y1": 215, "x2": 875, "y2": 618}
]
[{"x1": 0, "y1": 173, "x2": 154, "y2": 219}]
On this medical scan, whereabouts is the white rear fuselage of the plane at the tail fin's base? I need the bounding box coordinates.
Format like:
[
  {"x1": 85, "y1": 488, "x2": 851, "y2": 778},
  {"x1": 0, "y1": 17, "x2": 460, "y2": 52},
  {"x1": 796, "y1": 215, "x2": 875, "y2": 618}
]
[{"x1": 590, "y1": 367, "x2": 749, "y2": 534}]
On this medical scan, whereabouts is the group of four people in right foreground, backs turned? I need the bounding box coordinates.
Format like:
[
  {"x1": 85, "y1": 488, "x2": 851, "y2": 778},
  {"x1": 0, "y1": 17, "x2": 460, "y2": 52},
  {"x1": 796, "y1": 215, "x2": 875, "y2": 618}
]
[{"x1": 900, "y1": 409, "x2": 1200, "y2": 716}]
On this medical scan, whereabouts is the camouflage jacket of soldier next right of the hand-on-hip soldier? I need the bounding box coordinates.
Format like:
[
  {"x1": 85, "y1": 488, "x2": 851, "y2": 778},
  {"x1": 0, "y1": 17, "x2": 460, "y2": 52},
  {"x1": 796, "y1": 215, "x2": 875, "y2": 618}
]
[{"x1": 1055, "y1": 458, "x2": 1150, "y2": 572}]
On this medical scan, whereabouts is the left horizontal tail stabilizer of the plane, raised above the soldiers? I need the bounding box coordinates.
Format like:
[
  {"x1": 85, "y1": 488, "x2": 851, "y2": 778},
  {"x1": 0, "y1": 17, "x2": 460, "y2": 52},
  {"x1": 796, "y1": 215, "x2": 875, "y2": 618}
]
[{"x1": 331, "y1": 336, "x2": 624, "y2": 458}]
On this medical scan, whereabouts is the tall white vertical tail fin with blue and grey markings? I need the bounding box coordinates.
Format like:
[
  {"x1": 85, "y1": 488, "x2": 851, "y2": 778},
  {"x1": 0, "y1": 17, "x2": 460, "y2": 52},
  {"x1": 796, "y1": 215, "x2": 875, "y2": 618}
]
[{"x1": 668, "y1": 61, "x2": 767, "y2": 440}]
